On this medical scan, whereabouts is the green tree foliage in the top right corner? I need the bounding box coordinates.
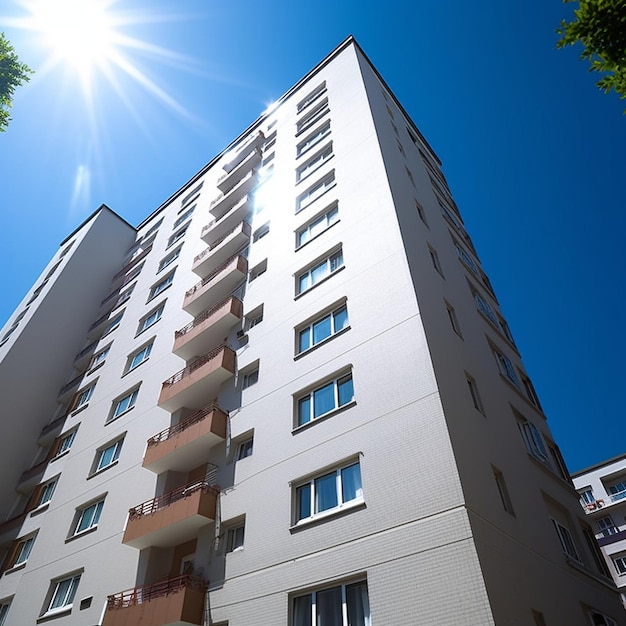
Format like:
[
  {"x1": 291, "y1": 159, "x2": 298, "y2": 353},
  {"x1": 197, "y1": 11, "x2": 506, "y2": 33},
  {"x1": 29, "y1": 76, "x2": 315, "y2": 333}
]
[{"x1": 556, "y1": 0, "x2": 626, "y2": 108}]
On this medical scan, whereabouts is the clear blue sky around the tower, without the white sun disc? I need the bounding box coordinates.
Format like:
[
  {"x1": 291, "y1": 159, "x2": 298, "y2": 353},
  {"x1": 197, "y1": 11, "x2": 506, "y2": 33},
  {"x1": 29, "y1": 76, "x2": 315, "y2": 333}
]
[{"x1": 0, "y1": 0, "x2": 626, "y2": 471}]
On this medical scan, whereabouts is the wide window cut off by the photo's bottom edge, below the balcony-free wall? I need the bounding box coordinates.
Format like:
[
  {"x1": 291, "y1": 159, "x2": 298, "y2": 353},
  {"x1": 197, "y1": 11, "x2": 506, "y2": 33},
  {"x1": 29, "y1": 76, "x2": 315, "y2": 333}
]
[{"x1": 293, "y1": 580, "x2": 372, "y2": 626}]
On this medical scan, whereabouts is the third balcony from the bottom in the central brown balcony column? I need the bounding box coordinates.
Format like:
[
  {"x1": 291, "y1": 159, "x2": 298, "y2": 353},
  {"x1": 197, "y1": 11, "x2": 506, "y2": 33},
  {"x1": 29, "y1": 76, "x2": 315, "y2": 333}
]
[{"x1": 143, "y1": 405, "x2": 227, "y2": 474}]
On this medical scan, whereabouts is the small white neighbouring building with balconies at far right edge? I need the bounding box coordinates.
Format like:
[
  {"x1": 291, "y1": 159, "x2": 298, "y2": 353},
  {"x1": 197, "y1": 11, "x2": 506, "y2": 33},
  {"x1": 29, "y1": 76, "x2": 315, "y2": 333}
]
[{"x1": 572, "y1": 454, "x2": 626, "y2": 605}]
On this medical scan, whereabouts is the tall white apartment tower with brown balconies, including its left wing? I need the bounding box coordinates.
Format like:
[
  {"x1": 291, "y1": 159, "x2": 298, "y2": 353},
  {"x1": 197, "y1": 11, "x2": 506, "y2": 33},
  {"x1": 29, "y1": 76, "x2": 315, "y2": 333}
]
[{"x1": 0, "y1": 38, "x2": 626, "y2": 626}]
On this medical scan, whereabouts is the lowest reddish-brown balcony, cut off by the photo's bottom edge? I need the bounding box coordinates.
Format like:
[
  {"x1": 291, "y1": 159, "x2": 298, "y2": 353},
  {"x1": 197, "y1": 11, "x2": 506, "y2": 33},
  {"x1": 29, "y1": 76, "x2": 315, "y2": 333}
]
[{"x1": 102, "y1": 575, "x2": 209, "y2": 626}]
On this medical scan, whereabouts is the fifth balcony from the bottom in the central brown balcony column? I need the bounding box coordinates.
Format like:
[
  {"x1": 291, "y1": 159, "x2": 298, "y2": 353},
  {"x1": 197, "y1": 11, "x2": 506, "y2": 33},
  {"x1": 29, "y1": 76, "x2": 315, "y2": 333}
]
[{"x1": 172, "y1": 296, "x2": 243, "y2": 361}]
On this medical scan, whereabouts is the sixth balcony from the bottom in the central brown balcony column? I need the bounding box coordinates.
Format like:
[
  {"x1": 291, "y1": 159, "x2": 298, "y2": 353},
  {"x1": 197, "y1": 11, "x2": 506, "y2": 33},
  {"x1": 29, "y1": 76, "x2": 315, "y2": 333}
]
[{"x1": 183, "y1": 255, "x2": 248, "y2": 317}]
